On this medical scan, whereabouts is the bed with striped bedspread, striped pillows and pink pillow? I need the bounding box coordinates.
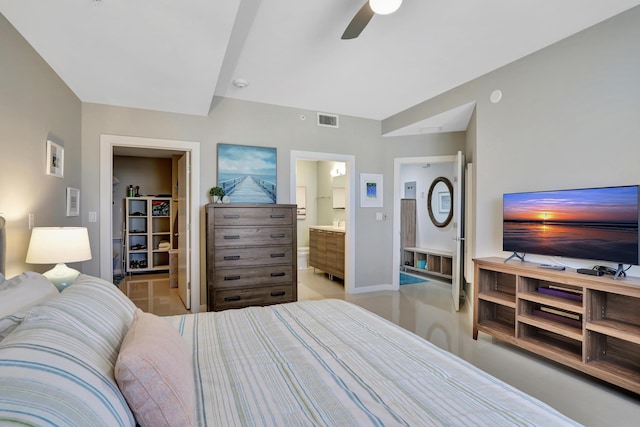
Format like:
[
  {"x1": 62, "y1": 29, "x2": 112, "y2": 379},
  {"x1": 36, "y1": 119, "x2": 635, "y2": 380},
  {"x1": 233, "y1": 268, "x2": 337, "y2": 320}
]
[{"x1": 0, "y1": 264, "x2": 577, "y2": 426}]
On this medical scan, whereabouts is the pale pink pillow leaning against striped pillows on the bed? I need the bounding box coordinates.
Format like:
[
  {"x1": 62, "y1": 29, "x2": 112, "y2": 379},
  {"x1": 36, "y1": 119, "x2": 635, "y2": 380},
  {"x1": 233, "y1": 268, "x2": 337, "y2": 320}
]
[{"x1": 114, "y1": 309, "x2": 196, "y2": 427}]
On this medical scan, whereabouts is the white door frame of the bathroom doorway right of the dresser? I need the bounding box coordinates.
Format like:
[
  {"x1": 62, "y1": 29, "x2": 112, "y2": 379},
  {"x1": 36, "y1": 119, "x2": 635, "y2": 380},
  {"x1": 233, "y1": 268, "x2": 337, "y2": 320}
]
[{"x1": 289, "y1": 150, "x2": 356, "y2": 294}]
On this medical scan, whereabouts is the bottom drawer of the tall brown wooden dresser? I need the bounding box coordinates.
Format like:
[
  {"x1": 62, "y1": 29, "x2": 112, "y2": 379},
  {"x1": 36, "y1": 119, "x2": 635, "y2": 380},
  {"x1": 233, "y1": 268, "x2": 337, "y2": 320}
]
[{"x1": 213, "y1": 285, "x2": 293, "y2": 311}]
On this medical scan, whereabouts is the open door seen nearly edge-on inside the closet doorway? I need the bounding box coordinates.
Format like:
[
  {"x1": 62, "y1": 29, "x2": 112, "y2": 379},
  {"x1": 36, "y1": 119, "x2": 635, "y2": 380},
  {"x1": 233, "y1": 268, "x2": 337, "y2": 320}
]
[{"x1": 178, "y1": 151, "x2": 191, "y2": 310}]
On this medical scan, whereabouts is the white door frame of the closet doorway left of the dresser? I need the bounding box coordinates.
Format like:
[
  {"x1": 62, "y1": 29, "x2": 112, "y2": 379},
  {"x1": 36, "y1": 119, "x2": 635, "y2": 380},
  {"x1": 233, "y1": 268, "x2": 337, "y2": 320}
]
[{"x1": 99, "y1": 134, "x2": 202, "y2": 313}]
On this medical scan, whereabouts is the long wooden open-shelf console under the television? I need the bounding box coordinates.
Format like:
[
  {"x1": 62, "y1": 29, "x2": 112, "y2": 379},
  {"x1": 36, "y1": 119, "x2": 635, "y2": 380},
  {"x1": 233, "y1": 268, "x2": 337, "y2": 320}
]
[{"x1": 473, "y1": 258, "x2": 640, "y2": 394}]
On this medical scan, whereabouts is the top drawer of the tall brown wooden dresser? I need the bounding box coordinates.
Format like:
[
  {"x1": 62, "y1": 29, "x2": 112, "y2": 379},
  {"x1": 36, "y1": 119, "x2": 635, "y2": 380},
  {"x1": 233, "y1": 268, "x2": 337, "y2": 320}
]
[{"x1": 213, "y1": 206, "x2": 293, "y2": 227}]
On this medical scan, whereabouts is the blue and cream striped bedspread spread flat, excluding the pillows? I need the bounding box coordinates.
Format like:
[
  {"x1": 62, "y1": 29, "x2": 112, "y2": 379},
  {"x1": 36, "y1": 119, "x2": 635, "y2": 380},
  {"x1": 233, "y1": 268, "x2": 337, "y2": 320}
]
[{"x1": 166, "y1": 300, "x2": 577, "y2": 426}]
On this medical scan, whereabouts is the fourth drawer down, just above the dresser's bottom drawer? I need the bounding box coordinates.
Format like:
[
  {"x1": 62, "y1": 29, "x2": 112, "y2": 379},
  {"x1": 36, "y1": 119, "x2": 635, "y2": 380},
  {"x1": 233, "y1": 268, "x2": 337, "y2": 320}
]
[{"x1": 214, "y1": 265, "x2": 293, "y2": 289}]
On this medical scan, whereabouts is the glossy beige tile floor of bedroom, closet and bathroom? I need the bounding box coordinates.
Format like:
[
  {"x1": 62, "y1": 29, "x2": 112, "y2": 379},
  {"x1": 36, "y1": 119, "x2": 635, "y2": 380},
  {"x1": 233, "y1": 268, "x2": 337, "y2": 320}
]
[{"x1": 120, "y1": 269, "x2": 640, "y2": 426}]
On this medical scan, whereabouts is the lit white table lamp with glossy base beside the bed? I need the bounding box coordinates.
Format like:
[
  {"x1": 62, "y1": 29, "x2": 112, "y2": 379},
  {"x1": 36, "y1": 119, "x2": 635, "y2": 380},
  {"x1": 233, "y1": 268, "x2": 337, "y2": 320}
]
[{"x1": 26, "y1": 227, "x2": 91, "y2": 292}]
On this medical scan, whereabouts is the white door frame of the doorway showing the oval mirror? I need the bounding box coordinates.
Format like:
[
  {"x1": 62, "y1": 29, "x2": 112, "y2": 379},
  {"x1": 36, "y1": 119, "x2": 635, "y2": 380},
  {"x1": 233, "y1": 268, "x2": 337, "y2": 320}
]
[{"x1": 392, "y1": 155, "x2": 457, "y2": 291}]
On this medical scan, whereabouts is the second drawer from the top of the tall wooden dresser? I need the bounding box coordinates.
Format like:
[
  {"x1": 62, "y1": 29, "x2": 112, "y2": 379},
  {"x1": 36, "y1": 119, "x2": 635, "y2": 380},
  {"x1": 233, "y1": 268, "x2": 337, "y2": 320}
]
[{"x1": 214, "y1": 227, "x2": 293, "y2": 248}]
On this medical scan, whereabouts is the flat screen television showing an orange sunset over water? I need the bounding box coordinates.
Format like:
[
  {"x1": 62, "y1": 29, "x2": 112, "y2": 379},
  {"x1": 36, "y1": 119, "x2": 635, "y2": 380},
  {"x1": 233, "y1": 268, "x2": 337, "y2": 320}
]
[{"x1": 502, "y1": 185, "x2": 640, "y2": 265}]
